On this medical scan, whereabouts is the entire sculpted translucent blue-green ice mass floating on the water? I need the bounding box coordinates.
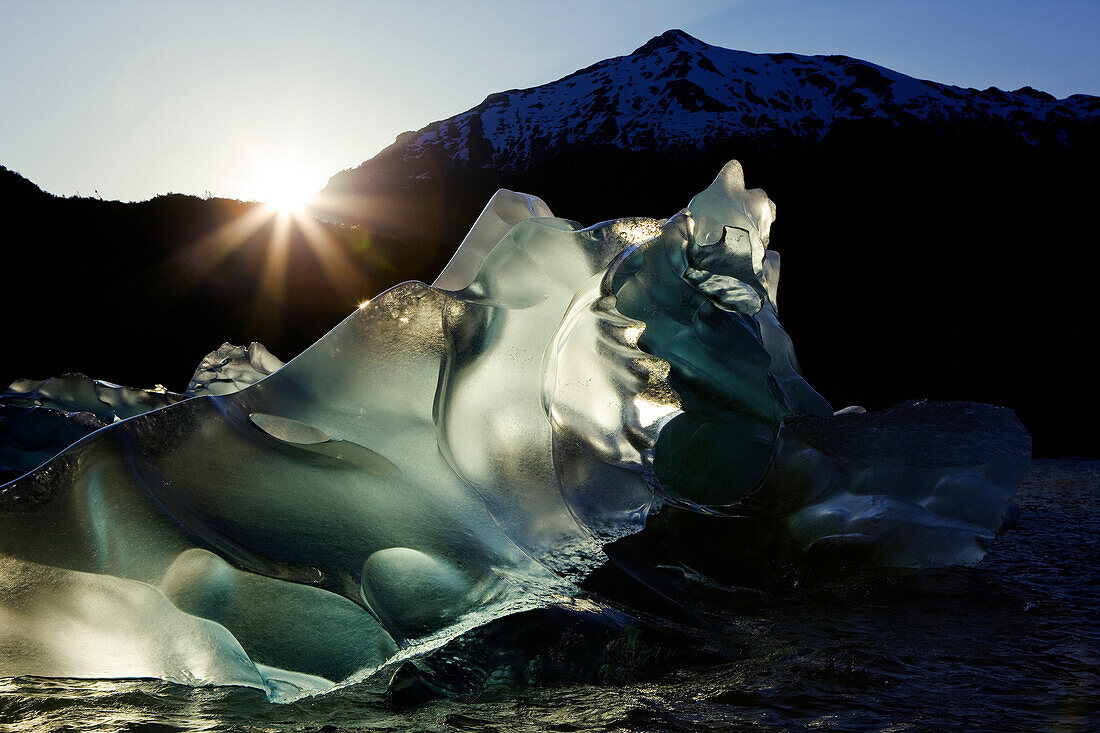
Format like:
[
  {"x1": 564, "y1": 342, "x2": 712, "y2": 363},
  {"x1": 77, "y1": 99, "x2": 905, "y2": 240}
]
[{"x1": 0, "y1": 162, "x2": 1031, "y2": 700}]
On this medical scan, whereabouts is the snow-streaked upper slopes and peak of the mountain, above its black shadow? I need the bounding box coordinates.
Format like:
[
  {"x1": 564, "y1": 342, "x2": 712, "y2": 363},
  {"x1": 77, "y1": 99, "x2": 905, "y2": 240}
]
[{"x1": 329, "y1": 30, "x2": 1100, "y2": 195}]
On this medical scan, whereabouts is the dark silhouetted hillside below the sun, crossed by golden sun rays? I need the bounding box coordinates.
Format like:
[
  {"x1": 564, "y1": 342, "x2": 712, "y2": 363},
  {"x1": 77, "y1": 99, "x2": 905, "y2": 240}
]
[{"x1": 0, "y1": 168, "x2": 438, "y2": 390}]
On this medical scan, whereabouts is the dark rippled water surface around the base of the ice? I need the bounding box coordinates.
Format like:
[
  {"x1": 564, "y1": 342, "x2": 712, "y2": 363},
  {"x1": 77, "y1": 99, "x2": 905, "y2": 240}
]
[{"x1": 0, "y1": 459, "x2": 1100, "y2": 733}]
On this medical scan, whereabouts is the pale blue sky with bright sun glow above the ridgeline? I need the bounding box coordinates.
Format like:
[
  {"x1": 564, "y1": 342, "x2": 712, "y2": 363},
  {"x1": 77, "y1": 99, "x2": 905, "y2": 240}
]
[{"x1": 0, "y1": 0, "x2": 1100, "y2": 200}]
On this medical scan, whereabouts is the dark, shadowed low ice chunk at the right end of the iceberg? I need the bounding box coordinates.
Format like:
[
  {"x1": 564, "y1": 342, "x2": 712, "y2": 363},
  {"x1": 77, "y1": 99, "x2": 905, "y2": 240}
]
[{"x1": 758, "y1": 402, "x2": 1031, "y2": 568}]
